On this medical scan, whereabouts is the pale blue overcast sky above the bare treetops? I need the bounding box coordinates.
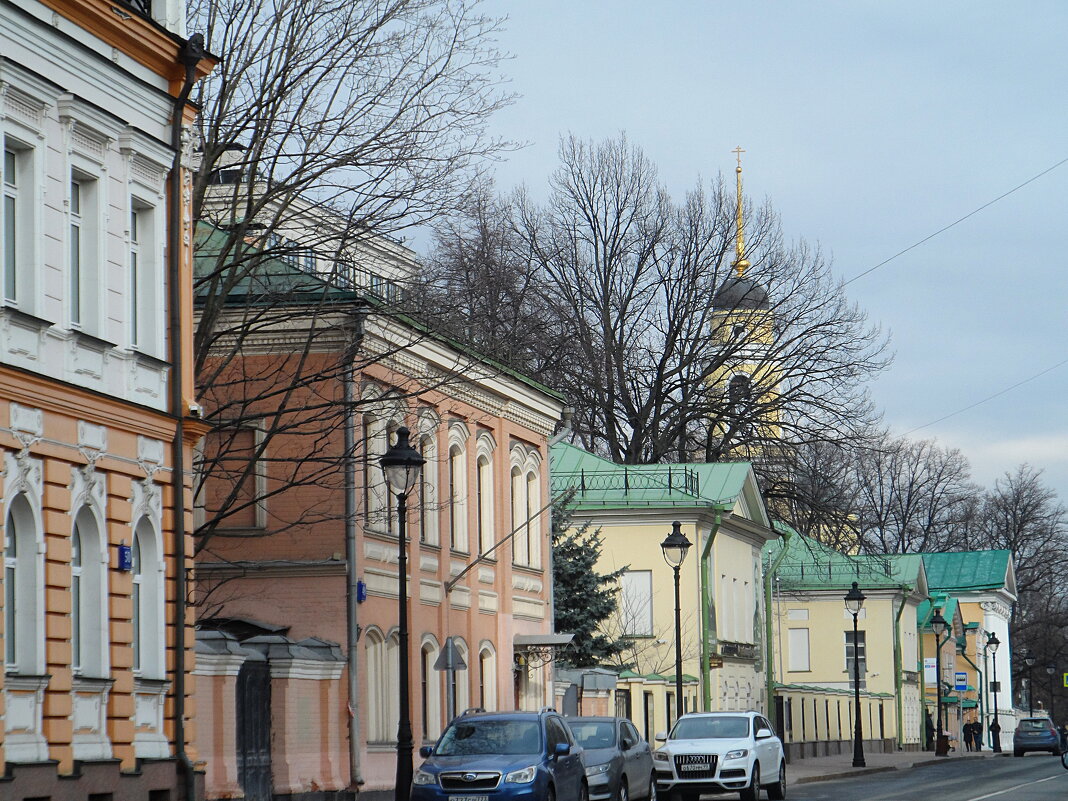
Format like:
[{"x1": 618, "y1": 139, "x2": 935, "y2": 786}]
[{"x1": 463, "y1": 0, "x2": 1068, "y2": 501}]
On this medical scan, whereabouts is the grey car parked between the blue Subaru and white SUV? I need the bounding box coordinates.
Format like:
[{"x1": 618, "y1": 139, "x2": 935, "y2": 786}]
[{"x1": 566, "y1": 718, "x2": 657, "y2": 801}]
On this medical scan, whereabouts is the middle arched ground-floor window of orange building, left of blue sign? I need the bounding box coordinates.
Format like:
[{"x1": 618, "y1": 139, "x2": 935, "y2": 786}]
[{"x1": 70, "y1": 506, "x2": 107, "y2": 678}]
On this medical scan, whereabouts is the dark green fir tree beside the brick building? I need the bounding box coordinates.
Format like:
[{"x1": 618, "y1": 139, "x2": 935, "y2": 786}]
[{"x1": 552, "y1": 497, "x2": 628, "y2": 668}]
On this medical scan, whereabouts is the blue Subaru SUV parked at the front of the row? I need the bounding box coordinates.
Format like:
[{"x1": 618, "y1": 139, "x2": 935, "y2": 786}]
[{"x1": 411, "y1": 709, "x2": 590, "y2": 801}]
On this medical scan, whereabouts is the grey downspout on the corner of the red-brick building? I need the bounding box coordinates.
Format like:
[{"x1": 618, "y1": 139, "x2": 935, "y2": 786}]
[{"x1": 350, "y1": 312, "x2": 363, "y2": 789}]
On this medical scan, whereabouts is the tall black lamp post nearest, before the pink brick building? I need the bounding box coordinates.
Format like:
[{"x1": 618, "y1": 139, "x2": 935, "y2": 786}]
[{"x1": 379, "y1": 426, "x2": 426, "y2": 801}]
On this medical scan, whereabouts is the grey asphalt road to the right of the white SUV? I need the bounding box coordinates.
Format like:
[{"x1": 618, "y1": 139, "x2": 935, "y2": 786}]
[{"x1": 786, "y1": 754, "x2": 1068, "y2": 801}]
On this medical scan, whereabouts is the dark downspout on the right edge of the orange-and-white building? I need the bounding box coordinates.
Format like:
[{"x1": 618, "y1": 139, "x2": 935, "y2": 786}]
[{"x1": 167, "y1": 33, "x2": 207, "y2": 801}]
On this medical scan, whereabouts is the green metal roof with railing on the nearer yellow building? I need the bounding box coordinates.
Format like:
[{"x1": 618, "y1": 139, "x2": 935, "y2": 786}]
[{"x1": 550, "y1": 442, "x2": 752, "y2": 509}]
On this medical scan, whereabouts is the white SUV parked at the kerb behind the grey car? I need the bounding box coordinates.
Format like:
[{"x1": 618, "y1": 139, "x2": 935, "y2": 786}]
[{"x1": 653, "y1": 712, "x2": 786, "y2": 801}]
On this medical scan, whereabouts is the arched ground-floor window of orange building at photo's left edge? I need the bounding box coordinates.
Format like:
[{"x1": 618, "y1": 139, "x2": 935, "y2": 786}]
[{"x1": 3, "y1": 494, "x2": 45, "y2": 675}]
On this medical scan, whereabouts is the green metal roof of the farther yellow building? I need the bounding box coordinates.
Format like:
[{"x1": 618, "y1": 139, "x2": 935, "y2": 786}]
[{"x1": 764, "y1": 536, "x2": 923, "y2": 592}]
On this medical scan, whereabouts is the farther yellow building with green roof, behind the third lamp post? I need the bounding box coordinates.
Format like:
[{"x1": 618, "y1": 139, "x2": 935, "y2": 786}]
[{"x1": 765, "y1": 532, "x2": 927, "y2": 756}]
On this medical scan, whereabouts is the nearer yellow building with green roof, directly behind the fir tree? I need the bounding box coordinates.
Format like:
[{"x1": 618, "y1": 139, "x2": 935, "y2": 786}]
[{"x1": 551, "y1": 443, "x2": 776, "y2": 737}]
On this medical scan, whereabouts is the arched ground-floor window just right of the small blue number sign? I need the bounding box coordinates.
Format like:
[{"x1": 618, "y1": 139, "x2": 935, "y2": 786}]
[{"x1": 131, "y1": 517, "x2": 163, "y2": 679}]
